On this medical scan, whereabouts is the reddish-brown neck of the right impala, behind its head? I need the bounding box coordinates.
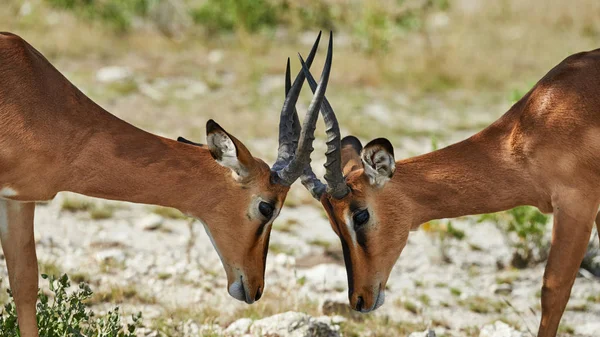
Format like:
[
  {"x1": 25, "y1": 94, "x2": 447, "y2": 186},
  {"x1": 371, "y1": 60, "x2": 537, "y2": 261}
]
[{"x1": 393, "y1": 123, "x2": 537, "y2": 225}]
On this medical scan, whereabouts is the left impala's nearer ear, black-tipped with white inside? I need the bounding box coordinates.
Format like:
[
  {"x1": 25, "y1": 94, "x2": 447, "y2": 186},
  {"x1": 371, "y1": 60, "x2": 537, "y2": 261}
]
[{"x1": 206, "y1": 119, "x2": 254, "y2": 181}]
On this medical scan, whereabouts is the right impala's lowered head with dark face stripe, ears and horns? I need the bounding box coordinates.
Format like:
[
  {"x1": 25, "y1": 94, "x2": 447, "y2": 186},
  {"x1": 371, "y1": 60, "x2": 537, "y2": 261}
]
[{"x1": 302, "y1": 56, "x2": 410, "y2": 312}]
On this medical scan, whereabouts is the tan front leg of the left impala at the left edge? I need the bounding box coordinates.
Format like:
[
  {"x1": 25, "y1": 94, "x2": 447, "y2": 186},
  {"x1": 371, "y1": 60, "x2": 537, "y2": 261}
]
[{"x1": 0, "y1": 200, "x2": 38, "y2": 337}]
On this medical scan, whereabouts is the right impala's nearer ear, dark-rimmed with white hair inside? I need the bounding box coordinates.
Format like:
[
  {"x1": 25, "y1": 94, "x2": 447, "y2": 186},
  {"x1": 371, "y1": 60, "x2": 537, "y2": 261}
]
[{"x1": 360, "y1": 138, "x2": 396, "y2": 188}]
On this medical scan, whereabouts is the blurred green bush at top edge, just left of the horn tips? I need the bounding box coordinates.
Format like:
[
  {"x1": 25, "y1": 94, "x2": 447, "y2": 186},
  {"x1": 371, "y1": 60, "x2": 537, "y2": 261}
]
[{"x1": 192, "y1": 0, "x2": 277, "y2": 33}]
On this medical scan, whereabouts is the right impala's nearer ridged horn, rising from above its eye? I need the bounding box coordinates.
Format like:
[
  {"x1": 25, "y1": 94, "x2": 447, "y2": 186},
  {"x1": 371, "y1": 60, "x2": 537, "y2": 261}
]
[{"x1": 300, "y1": 51, "x2": 350, "y2": 199}]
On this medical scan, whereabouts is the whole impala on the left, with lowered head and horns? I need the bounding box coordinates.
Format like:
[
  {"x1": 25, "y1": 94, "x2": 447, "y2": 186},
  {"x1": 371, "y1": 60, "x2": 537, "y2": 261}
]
[{"x1": 0, "y1": 33, "x2": 332, "y2": 337}]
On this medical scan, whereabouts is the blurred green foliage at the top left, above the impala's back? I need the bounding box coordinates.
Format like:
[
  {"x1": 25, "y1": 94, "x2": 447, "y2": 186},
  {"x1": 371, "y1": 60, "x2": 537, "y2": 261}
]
[{"x1": 46, "y1": 0, "x2": 155, "y2": 32}]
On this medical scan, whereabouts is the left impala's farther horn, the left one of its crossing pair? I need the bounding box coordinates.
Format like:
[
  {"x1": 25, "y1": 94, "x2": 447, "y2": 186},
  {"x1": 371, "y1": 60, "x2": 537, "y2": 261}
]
[{"x1": 271, "y1": 32, "x2": 321, "y2": 172}]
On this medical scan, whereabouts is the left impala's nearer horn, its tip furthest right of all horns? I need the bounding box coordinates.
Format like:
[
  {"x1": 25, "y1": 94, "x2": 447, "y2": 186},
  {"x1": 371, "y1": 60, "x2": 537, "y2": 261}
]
[{"x1": 278, "y1": 32, "x2": 333, "y2": 183}]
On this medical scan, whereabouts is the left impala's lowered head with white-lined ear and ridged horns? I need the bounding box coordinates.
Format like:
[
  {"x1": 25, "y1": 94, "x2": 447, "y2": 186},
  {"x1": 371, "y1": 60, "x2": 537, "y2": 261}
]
[{"x1": 179, "y1": 34, "x2": 332, "y2": 304}]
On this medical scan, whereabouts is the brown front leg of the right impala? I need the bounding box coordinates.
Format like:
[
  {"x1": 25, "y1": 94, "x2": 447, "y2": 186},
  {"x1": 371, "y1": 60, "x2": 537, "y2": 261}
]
[{"x1": 538, "y1": 200, "x2": 598, "y2": 337}]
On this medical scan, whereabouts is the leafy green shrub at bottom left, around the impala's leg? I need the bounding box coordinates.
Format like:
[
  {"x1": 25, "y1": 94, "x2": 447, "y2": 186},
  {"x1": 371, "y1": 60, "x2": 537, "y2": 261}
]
[{"x1": 0, "y1": 274, "x2": 142, "y2": 337}]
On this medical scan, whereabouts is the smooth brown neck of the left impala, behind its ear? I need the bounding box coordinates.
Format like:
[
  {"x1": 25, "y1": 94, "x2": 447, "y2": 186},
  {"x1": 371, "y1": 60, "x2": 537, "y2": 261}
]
[{"x1": 63, "y1": 116, "x2": 227, "y2": 212}]
